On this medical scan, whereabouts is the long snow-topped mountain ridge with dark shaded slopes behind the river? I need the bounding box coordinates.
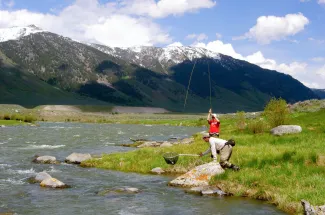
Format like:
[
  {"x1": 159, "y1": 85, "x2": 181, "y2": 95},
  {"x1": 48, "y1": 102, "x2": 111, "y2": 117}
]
[{"x1": 0, "y1": 26, "x2": 318, "y2": 112}]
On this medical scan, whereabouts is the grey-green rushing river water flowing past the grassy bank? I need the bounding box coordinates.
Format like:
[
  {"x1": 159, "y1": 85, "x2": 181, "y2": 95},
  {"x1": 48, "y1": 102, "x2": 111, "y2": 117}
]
[{"x1": 0, "y1": 123, "x2": 283, "y2": 215}]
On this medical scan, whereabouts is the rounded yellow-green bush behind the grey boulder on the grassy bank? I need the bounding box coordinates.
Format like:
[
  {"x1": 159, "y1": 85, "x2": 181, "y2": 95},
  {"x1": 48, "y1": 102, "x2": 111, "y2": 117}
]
[{"x1": 264, "y1": 98, "x2": 290, "y2": 127}]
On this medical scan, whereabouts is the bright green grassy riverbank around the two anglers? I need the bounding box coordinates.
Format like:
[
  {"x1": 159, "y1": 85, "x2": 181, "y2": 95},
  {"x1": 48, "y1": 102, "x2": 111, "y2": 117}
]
[{"x1": 82, "y1": 109, "x2": 325, "y2": 214}]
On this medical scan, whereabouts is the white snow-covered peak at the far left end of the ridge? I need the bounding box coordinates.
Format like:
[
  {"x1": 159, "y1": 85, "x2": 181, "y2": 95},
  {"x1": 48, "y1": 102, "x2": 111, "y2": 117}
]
[{"x1": 0, "y1": 25, "x2": 43, "y2": 42}]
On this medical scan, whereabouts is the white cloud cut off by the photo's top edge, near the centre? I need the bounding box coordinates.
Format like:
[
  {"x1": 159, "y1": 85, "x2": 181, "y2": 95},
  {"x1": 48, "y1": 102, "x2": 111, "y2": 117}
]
[{"x1": 116, "y1": 0, "x2": 216, "y2": 18}]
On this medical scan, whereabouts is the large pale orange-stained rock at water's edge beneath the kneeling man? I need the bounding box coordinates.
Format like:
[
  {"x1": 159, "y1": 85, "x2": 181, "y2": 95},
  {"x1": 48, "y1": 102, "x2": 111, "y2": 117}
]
[{"x1": 169, "y1": 162, "x2": 225, "y2": 187}]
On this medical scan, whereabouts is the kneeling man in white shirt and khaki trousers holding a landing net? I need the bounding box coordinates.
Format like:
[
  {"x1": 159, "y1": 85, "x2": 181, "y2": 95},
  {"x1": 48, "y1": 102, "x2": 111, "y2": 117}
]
[{"x1": 199, "y1": 133, "x2": 239, "y2": 171}]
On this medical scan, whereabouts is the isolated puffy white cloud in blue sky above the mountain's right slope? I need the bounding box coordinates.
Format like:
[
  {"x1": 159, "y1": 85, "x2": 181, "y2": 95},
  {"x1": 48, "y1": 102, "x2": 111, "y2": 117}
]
[{"x1": 233, "y1": 13, "x2": 309, "y2": 44}]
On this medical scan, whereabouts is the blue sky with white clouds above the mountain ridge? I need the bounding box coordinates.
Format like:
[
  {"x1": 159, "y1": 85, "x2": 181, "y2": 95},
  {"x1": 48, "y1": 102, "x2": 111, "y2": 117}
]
[{"x1": 0, "y1": 0, "x2": 325, "y2": 89}]
